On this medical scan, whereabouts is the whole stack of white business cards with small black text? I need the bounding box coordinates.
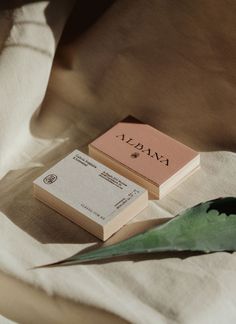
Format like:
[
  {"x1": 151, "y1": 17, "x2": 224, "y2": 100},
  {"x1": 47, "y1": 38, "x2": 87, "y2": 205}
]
[{"x1": 34, "y1": 150, "x2": 148, "y2": 240}]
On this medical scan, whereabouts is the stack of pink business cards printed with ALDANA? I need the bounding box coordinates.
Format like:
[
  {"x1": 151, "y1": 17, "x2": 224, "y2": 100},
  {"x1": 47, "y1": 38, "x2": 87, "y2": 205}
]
[{"x1": 89, "y1": 116, "x2": 200, "y2": 199}]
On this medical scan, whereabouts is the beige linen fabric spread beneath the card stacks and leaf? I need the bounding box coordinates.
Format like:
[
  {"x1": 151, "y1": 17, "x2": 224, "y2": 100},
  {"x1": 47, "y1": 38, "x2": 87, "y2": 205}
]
[{"x1": 0, "y1": 0, "x2": 236, "y2": 323}]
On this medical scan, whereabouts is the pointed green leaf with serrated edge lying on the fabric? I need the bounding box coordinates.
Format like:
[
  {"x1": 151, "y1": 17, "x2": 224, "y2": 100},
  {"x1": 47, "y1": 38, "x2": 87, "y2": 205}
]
[{"x1": 34, "y1": 197, "x2": 236, "y2": 267}]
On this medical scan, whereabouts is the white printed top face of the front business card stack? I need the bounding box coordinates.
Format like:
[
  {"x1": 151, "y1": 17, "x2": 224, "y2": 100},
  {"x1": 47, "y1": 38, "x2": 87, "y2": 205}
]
[{"x1": 34, "y1": 150, "x2": 146, "y2": 226}]
